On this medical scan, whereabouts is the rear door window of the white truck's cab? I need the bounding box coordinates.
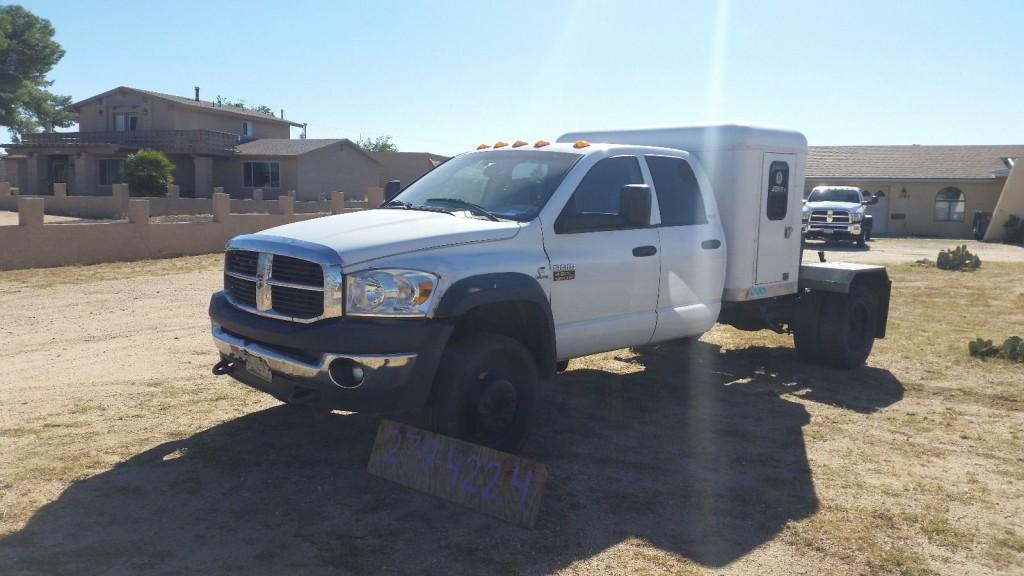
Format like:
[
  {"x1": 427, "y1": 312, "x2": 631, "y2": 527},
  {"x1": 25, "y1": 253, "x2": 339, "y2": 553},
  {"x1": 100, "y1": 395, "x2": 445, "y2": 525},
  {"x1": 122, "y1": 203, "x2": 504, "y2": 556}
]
[{"x1": 644, "y1": 156, "x2": 708, "y2": 227}]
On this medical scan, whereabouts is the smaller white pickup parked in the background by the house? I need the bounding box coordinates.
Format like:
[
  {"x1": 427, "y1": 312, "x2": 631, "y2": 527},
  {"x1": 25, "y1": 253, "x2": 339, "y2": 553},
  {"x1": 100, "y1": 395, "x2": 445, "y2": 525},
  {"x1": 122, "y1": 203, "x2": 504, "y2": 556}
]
[{"x1": 803, "y1": 186, "x2": 885, "y2": 248}]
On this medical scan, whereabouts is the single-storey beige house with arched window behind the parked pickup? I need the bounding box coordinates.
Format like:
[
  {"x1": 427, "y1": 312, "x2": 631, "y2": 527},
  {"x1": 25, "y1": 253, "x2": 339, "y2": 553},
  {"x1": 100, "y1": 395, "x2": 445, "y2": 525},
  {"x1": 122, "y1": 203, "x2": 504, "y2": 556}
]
[{"x1": 805, "y1": 146, "x2": 1024, "y2": 238}]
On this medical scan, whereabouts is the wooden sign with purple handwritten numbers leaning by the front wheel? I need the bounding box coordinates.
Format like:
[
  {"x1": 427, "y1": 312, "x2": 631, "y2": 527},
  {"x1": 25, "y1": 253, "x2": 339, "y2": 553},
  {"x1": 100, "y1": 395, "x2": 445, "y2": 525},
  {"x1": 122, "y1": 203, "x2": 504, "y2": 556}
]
[{"x1": 367, "y1": 420, "x2": 548, "y2": 528}]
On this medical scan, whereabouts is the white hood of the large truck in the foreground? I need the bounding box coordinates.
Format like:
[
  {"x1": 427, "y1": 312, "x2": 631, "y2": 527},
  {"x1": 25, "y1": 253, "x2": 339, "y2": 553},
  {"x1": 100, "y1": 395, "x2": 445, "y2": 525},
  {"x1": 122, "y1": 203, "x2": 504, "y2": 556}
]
[{"x1": 246, "y1": 208, "x2": 520, "y2": 266}]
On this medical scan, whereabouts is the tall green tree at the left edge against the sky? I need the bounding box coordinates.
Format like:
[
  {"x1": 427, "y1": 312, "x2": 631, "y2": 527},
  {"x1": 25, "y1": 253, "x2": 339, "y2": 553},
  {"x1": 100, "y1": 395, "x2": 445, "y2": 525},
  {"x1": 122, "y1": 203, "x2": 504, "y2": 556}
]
[{"x1": 0, "y1": 6, "x2": 75, "y2": 141}]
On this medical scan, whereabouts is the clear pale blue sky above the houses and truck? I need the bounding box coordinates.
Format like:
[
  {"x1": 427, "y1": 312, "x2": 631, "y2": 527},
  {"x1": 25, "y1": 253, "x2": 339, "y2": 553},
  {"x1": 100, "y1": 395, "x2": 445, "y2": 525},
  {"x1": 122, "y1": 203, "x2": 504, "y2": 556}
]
[{"x1": 16, "y1": 0, "x2": 1024, "y2": 154}]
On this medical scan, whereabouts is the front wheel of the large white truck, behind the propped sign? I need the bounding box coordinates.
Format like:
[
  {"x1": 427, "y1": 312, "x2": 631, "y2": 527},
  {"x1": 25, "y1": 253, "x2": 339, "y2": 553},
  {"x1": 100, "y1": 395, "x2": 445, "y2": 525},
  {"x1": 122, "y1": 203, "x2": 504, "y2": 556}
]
[{"x1": 424, "y1": 333, "x2": 540, "y2": 452}]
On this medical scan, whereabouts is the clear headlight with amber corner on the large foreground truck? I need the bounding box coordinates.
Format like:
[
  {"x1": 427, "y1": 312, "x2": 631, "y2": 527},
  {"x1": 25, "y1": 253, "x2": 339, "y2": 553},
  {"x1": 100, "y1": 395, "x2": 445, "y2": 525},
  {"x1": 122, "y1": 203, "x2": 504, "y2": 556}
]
[{"x1": 345, "y1": 270, "x2": 437, "y2": 317}]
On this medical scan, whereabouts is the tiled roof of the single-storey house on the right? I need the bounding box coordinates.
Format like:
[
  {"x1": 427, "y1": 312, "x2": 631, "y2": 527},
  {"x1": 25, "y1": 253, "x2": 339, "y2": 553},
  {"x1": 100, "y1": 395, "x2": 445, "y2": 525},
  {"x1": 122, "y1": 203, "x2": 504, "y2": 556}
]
[{"x1": 807, "y1": 146, "x2": 1024, "y2": 179}]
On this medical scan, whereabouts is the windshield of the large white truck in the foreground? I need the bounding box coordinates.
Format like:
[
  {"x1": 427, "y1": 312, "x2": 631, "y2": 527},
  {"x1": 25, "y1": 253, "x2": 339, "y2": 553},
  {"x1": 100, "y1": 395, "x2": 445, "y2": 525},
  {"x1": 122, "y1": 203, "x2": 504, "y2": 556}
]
[{"x1": 391, "y1": 150, "x2": 581, "y2": 222}]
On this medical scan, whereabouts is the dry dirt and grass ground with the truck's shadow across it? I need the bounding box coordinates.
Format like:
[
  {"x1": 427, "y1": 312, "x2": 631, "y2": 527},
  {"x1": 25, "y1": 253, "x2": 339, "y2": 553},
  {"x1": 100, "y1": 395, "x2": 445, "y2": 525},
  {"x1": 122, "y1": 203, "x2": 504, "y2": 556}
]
[{"x1": 0, "y1": 240, "x2": 1024, "y2": 575}]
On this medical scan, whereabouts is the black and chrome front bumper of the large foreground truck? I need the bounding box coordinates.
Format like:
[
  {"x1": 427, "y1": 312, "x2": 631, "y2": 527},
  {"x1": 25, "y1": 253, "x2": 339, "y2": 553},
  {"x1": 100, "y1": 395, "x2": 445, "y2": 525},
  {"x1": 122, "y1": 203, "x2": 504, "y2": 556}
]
[{"x1": 210, "y1": 292, "x2": 452, "y2": 412}]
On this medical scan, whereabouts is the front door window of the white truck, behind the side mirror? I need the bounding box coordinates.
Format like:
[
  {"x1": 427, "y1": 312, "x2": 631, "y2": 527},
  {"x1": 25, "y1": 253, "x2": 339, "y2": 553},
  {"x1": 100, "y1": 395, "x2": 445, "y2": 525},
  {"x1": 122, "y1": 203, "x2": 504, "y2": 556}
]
[{"x1": 555, "y1": 156, "x2": 644, "y2": 234}]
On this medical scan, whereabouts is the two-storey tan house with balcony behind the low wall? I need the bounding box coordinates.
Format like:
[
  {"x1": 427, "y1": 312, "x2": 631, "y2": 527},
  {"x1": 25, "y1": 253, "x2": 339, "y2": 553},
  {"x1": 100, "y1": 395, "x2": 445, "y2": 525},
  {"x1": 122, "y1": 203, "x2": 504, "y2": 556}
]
[{"x1": 4, "y1": 86, "x2": 429, "y2": 200}]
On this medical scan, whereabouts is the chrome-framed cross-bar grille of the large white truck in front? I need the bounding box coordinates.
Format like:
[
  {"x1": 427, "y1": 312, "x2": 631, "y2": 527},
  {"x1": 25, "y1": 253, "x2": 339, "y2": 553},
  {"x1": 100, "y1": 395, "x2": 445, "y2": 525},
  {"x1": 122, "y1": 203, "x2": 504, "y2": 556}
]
[{"x1": 224, "y1": 248, "x2": 340, "y2": 322}]
